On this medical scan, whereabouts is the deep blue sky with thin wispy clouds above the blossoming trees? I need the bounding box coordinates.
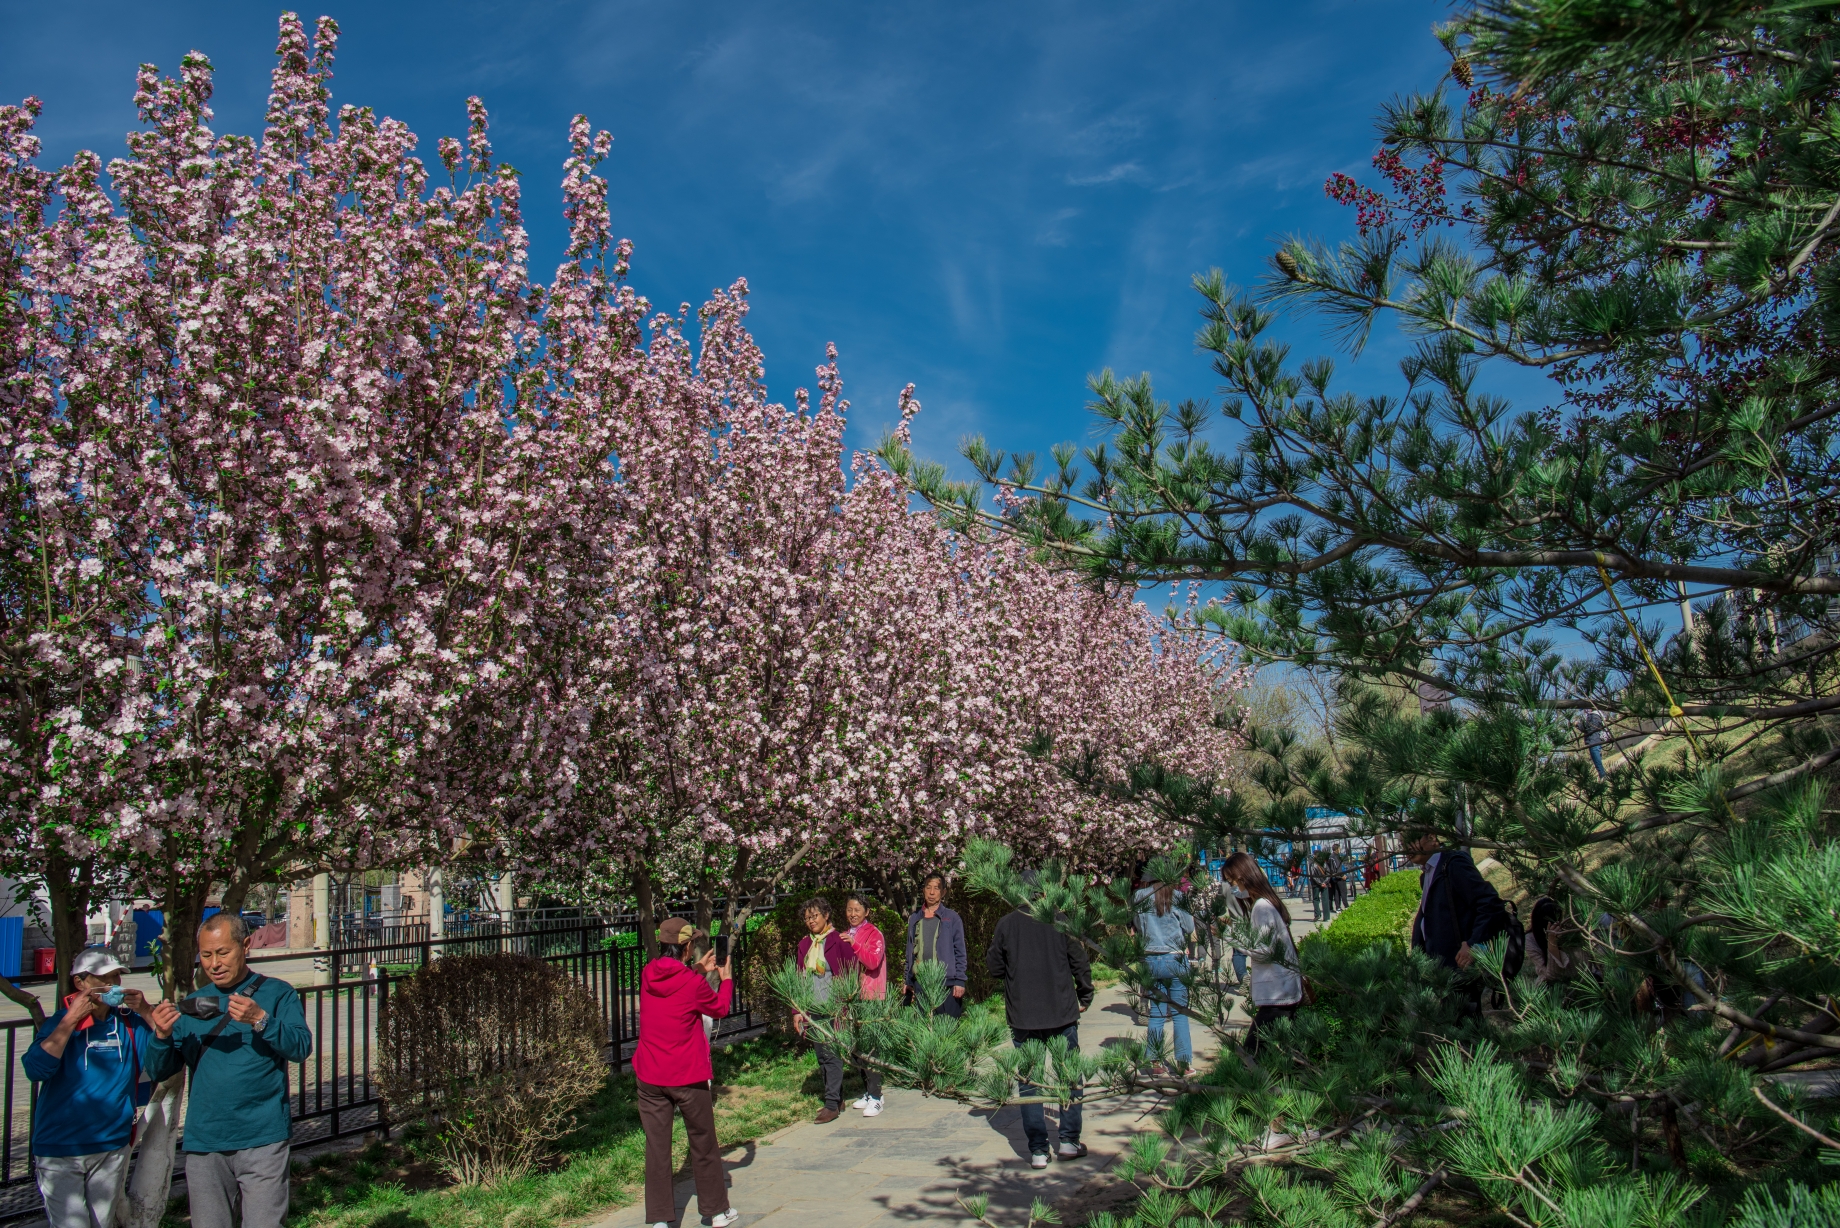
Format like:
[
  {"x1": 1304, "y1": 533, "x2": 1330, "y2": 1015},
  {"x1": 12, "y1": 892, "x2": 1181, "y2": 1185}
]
[{"x1": 0, "y1": 0, "x2": 1531, "y2": 478}]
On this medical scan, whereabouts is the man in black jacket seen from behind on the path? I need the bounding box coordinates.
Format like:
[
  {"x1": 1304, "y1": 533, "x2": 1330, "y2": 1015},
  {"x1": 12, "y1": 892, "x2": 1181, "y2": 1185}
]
[{"x1": 984, "y1": 909, "x2": 1093, "y2": 1169}]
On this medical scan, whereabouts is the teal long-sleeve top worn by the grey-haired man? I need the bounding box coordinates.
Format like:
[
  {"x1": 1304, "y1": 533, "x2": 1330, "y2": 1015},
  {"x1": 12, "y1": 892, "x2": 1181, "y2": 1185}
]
[{"x1": 147, "y1": 972, "x2": 313, "y2": 1153}]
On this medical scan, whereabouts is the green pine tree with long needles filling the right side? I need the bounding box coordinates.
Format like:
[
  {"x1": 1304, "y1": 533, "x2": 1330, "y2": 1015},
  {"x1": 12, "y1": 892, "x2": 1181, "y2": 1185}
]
[{"x1": 848, "y1": 0, "x2": 1840, "y2": 1228}]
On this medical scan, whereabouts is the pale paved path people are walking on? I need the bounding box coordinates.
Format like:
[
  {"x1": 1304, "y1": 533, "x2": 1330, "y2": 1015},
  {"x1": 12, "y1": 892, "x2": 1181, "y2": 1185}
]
[{"x1": 592, "y1": 904, "x2": 1316, "y2": 1228}]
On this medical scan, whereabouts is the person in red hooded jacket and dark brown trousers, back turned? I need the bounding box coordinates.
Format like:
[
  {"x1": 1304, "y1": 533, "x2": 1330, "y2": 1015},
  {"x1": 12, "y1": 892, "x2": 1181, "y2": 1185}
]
[{"x1": 633, "y1": 917, "x2": 742, "y2": 1228}]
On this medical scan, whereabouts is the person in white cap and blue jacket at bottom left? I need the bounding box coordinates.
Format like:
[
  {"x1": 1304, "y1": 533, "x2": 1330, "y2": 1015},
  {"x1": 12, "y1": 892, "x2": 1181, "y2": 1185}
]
[{"x1": 20, "y1": 948, "x2": 153, "y2": 1228}]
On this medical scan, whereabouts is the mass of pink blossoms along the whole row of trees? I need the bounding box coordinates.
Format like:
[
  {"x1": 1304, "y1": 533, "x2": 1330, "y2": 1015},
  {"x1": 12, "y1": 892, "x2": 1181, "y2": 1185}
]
[{"x1": 0, "y1": 15, "x2": 1238, "y2": 902}]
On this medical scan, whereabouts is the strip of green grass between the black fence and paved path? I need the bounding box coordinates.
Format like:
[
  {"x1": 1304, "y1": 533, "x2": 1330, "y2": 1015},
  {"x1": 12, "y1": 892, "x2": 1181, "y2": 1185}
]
[{"x1": 233, "y1": 1038, "x2": 831, "y2": 1228}]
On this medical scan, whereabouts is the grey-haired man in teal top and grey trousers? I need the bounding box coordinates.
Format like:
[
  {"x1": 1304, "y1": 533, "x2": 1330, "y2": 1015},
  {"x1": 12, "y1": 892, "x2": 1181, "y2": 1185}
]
[{"x1": 147, "y1": 913, "x2": 313, "y2": 1228}]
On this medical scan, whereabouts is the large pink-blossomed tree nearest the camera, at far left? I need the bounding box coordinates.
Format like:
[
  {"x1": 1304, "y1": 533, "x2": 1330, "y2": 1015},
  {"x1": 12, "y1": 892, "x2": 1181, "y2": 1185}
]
[{"x1": 0, "y1": 15, "x2": 530, "y2": 981}]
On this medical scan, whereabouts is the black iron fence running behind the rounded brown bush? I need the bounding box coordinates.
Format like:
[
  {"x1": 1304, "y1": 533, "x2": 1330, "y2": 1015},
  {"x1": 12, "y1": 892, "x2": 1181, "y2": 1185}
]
[{"x1": 0, "y1": 909, "x2": 758, "y2": 1221}]
